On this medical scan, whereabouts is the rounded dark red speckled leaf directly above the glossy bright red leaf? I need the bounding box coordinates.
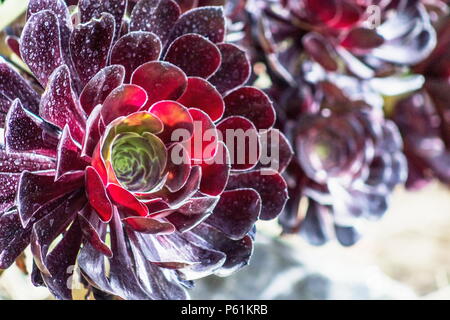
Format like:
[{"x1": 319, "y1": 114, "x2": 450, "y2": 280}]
[{"x1": 164, "y1": 33, "x2": 222, "y2": 78}]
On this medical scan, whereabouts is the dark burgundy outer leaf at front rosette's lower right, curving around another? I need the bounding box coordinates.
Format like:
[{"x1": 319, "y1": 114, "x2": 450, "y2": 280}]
[{"x1": 227, "y1": 169, "x2": 288, "y2": 220}]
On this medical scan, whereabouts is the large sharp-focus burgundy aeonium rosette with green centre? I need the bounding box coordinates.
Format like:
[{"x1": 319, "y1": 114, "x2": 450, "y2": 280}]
[{"x1": 0, "y1": 0, "x2": 291, "y2": 299}]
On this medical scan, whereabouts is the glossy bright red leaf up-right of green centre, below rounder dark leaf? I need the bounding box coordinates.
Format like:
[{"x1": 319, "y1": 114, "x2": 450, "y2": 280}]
[{"x1": 178, "y1": 78, "x2": 225, "y2": 121}]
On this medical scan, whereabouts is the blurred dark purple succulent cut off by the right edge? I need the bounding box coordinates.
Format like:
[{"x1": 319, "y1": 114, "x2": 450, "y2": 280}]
[{"x1": 393, "y1": 16, "x2": 450, "y2": 188}]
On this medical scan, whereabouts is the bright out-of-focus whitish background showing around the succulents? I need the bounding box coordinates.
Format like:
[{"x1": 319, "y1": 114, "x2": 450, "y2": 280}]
[{"x1": 0, "y1": 0, "x2": 450, "y2": 299}]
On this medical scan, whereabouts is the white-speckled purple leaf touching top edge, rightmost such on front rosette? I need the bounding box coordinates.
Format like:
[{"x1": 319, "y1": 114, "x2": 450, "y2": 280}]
[{"x1": 130, "y1": 0, "x2": 181, "y2": 45}]
